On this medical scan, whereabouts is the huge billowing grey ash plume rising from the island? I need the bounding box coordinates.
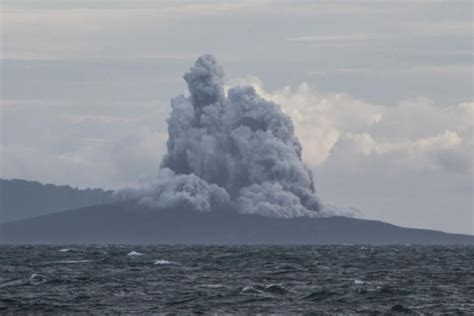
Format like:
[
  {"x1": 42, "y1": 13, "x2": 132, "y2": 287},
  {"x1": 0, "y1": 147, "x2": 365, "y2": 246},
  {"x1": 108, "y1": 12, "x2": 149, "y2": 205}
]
[{"x1": 117, "y1": 55, "x2": 324, "y2": 218}]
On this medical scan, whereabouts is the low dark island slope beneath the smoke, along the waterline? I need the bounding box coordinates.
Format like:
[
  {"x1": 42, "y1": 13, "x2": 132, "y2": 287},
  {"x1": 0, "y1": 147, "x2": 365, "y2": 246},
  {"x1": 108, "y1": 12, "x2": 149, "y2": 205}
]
[{"x1": 0, "y1": 205, "x2": 474, "y2": 245}]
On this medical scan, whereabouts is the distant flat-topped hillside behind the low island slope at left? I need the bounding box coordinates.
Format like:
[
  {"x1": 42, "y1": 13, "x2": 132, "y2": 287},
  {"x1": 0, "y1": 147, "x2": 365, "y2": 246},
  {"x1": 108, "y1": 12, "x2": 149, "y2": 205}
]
[{"x1": 0, "y1": 179, "x2": 112, "y2": 223}]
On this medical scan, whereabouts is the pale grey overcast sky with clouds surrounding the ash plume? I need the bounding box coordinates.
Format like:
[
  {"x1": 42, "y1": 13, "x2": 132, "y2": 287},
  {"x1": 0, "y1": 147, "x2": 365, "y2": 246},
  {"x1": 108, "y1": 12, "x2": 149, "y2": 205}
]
[{"x1": 0, "y1": 0, "x2": 474, "y2": 234}]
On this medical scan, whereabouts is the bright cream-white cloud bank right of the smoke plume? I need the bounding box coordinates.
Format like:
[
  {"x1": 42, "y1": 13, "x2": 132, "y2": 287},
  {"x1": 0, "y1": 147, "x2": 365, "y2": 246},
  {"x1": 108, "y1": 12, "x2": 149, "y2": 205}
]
[{"x1": 234, "y1": 77, "x2": 474, "y2": 175}]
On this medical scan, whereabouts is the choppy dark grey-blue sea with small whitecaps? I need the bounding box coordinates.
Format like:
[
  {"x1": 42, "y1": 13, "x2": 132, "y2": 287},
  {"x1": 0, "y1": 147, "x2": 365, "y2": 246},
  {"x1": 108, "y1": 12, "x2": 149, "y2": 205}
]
[{"x1": 0, "y1": 245, "x2": 474, "y2": 314}]
